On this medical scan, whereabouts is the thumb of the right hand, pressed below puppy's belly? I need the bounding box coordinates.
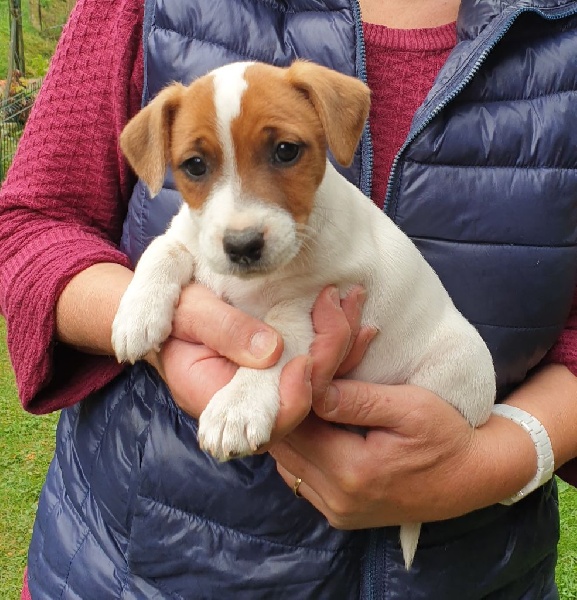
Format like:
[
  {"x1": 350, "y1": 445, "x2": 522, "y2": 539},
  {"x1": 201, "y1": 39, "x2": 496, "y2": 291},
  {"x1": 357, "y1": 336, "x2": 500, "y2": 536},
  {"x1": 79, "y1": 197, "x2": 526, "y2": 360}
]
[{"x1": 313, "y1": 379, "x2": 418, "y2": 428}]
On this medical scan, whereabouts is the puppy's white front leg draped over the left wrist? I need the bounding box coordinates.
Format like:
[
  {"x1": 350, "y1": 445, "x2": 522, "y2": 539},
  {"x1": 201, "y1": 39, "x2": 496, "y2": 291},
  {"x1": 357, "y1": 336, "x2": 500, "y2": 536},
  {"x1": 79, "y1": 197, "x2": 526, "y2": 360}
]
[{"x1": 112, "y1": 213, "x2": 194, "y2": 363}]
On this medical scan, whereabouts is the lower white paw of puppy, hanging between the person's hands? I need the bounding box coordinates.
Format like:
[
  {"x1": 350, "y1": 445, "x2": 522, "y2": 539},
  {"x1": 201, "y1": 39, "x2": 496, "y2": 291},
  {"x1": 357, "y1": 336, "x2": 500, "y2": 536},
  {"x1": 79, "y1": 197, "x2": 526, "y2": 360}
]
[{"x1": 198, "y1": 379, "x2": 279, "y2": 461}]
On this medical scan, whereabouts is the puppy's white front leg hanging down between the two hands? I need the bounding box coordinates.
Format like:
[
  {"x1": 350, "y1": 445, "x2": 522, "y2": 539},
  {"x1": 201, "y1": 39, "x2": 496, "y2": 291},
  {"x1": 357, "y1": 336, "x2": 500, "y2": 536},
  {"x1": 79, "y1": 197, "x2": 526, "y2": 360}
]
[{"x1": 198, "y1": 298, "x2": 314, "y2": 461}]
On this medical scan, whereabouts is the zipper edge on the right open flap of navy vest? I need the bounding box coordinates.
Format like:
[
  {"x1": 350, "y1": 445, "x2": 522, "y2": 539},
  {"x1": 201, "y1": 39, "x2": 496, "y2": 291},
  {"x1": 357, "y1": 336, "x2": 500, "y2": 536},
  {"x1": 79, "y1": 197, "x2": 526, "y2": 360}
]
[{"x1": 383, "y1": 2, "x2": 577, "y2": 217}]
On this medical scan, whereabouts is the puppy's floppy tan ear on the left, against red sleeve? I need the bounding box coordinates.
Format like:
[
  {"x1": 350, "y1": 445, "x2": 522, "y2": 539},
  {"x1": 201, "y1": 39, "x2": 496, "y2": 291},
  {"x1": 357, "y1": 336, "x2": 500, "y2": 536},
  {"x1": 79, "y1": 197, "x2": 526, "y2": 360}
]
[{"x1": 120, "y1": 83, "x2": 185, "y2": 196}]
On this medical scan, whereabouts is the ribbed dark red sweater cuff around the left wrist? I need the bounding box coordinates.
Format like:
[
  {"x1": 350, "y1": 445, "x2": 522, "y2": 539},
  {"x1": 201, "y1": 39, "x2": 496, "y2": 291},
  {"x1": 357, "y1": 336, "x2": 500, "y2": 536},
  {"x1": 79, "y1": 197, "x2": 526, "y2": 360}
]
[{"x1": 0, "y1": 226, "x2": 130, "y2": 414}]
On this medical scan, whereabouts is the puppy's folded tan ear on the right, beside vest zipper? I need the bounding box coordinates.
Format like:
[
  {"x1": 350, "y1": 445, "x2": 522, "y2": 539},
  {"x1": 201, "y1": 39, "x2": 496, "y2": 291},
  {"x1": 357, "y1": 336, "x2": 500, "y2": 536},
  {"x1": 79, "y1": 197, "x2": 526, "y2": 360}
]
[{"x1": 287, "y1": 60, "x2": 370, "y2": 167}]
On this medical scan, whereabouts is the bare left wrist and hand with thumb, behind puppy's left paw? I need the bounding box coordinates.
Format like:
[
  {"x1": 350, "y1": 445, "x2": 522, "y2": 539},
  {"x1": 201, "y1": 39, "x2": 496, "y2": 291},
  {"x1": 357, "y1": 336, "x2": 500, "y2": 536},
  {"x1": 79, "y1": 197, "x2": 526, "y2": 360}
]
[{"x1": 56, "y1": 263, "x2": 288, "y2": 416}]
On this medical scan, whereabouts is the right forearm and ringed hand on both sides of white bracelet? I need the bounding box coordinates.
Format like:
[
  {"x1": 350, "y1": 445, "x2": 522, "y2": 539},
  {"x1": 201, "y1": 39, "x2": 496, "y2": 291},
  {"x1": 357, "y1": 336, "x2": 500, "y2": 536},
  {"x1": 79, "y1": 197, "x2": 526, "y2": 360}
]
[{"x1": 272, "y1": 357, "x2": 577, "y2": 529}]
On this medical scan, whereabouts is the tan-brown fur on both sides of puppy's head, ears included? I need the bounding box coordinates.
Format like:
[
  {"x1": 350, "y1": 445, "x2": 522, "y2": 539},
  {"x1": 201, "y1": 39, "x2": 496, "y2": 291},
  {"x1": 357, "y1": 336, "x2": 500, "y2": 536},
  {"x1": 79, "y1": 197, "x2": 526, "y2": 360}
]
[{"x1": 126, "y1": 61, "x2": 369, "y2": 223}]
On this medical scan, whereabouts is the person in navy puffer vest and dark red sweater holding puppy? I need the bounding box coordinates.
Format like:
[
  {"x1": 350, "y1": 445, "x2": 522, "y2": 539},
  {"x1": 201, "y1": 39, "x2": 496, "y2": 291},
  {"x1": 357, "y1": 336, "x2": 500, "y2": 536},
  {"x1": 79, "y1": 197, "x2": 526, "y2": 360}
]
[{"x1": 0, "y1": 0, "x2": 577, "y2": 600}]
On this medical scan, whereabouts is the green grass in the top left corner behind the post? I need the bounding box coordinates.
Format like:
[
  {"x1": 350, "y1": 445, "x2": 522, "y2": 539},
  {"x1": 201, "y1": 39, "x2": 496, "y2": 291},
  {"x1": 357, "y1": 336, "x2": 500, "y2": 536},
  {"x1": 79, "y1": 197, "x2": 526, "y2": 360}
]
[{"x1": 0, "y1": 0, "x2": 68, "y2": 79}]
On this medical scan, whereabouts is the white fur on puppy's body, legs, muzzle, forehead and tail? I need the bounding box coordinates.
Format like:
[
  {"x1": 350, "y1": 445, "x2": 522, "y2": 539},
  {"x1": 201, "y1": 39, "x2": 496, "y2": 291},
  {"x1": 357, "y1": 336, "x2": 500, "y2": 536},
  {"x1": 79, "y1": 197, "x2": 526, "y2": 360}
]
[{"x1": 112, "y1": 66, "x2": 495, "y2": 566}]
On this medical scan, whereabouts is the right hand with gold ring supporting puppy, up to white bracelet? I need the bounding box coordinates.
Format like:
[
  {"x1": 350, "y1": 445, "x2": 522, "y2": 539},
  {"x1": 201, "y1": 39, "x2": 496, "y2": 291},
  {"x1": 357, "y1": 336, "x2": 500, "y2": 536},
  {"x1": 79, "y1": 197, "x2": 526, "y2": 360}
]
[{"x1": 270, "y1": 380, "x2": 508, "y2": 529}]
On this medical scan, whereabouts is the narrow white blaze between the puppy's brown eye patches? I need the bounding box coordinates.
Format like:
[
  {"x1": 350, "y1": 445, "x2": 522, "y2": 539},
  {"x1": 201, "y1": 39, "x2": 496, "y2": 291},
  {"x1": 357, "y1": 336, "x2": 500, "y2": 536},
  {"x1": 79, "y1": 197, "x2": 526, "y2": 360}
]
[{"x1": 213, "y1": 62, "x2": 253, "y2": 180}]
